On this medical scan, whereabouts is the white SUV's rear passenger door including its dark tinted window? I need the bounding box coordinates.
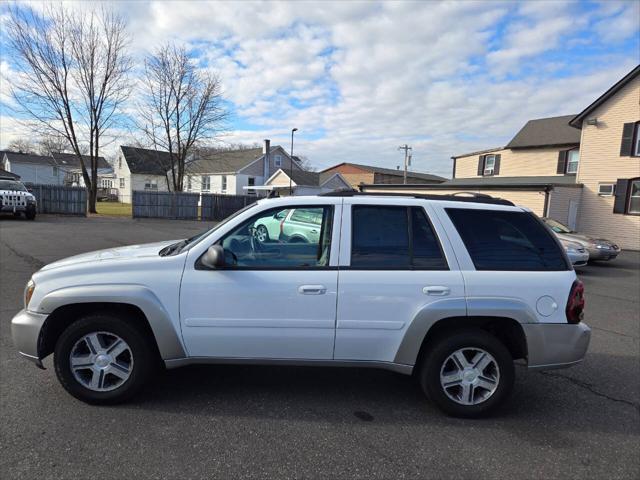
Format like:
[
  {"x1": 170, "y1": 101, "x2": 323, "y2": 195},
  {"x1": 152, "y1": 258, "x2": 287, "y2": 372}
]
[{"x1": 334, "y1": 199, "x2": 465, "y2": 362}]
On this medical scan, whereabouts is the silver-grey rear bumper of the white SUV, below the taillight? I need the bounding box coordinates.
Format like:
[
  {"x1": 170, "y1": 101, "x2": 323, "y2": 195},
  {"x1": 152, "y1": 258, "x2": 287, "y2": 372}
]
[{"x1": 522, "y1": 323, "x2": 591, "y2": 370}]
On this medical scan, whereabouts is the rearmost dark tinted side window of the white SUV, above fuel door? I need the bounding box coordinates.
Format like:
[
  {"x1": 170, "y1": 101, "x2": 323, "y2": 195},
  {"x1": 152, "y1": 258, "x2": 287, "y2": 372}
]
[{"x1": 446, "y1": 208, "x2": 569, "y2": 271}]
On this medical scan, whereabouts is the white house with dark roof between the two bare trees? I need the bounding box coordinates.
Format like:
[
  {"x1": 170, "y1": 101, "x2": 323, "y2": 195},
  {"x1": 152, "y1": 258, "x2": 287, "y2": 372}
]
[{"x1": 114, "y1": 145, "x2": 171, "y2": 203}]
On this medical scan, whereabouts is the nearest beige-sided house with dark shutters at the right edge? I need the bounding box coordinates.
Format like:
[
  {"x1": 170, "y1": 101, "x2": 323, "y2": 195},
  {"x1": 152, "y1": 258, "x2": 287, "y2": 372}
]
[{"x1": 570, "y1": 66, "x2": 640, "y2": 250}]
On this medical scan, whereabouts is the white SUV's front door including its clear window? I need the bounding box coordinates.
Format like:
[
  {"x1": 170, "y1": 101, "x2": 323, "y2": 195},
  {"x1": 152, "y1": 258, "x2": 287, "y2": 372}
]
[{"x1": 180, "y1": 204, "x2": 341, "y2": 359}]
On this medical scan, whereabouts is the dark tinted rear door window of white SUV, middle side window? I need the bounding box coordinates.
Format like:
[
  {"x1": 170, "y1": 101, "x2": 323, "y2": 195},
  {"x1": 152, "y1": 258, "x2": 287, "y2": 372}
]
[{"x1": 351, "y1": 205, "x2": 448, "y2": 270}]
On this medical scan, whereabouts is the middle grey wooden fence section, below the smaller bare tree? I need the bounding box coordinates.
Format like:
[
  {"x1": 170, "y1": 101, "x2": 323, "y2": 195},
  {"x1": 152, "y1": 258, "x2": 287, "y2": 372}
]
[{"x1": 132, "y1": 190, "x2": 200, "y2": 220}]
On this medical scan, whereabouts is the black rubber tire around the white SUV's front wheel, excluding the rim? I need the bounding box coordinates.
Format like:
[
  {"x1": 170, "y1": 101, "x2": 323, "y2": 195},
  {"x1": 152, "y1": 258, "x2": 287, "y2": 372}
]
[{"x1": 53, "y1": 313, "x2": 157, "y2": 405}]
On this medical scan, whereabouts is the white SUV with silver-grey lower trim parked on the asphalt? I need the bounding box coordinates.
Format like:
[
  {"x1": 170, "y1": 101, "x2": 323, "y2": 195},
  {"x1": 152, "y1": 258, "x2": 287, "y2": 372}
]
[{"x1": 12, "y1": 193, "x2": 590, "y2": 417}]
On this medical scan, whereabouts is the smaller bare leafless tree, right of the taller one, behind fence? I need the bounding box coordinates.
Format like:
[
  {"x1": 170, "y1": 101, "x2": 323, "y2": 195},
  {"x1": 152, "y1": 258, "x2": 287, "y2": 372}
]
[{"x1": 138, "y1": 44, "x2": 227, "y2": 192}]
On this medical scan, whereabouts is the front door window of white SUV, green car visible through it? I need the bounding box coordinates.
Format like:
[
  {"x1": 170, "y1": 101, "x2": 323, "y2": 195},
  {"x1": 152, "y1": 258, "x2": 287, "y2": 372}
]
[{"x1": 220, "y1": 206, "x2": 333, "y2": 269}]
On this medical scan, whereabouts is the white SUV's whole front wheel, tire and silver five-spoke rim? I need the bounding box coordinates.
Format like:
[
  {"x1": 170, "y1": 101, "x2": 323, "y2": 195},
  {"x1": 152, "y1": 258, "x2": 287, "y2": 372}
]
[{"x1": 54, "y1": 314, "x2": 154, "y2": 404}]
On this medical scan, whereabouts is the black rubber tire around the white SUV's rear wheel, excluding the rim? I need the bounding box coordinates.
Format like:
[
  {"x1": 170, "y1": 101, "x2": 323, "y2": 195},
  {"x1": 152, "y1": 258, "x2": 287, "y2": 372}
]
[{"x1": 418, "y1": 329, "x2": 515, "y2": 418}]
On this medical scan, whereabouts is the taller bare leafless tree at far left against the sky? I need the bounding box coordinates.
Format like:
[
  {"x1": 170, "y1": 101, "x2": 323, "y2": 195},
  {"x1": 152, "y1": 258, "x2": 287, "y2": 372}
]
[{"x1": 6, "y1": 5, "x2": 131, "y2": 212}]
